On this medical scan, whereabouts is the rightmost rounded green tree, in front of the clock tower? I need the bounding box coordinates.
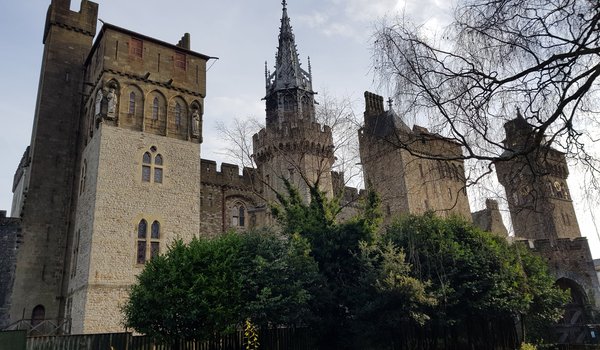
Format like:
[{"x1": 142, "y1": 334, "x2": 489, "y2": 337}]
[{"x1": 385, "y1": 213, "x2": 566, "y2": 346}]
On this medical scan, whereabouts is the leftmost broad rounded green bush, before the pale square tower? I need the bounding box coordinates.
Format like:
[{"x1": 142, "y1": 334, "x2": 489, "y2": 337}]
[{"x1": 123, "y1": 231, "x2": 316, "y2": 342}]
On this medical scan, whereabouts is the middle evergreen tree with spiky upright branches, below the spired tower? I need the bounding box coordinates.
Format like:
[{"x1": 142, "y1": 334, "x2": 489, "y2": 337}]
[{"x1": 273, "y1": 180, "x2": 435, "y2": 349}]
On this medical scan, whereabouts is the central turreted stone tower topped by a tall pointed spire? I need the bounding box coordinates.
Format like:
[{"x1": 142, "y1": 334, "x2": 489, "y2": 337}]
[{"x1": 253, "y1": 1, "x2": 334, "y2": 205}]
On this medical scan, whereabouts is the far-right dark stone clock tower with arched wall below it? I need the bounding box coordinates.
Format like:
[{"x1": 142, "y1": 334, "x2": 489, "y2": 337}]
[{"x1": 494, "y1": 112, "x2": 600, "y2": 320}]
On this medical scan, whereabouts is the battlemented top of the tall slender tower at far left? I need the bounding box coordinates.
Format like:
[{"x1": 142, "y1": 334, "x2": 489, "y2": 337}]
[{"x1": 43, "y1": 0, "x2": 98, "y2": 44}]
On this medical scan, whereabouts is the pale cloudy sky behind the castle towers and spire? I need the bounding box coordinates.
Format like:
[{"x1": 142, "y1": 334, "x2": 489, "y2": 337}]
[{"x1": 0, "y1": 0, "x2": 600, "y2": 258}]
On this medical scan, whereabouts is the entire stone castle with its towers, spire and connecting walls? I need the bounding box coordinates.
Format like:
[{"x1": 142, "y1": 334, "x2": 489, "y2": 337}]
[{"x1": 0, "y1": 0, "x2": 600, "y2": 340}]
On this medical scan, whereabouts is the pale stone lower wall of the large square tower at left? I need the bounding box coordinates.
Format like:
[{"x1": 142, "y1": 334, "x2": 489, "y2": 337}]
[{"x1": 69, "y1": 125, "x2": 200, "y2": 333}]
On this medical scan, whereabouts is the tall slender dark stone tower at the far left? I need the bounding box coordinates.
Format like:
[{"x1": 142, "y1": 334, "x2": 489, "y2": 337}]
[{"x1": 10, "y1": 0, "x2": 98, "y2": 328}]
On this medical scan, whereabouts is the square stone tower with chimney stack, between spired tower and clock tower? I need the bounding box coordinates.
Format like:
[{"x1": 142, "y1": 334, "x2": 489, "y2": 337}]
[{"x1": 358, "y1": 91, "x2": 471, "y2": 222}]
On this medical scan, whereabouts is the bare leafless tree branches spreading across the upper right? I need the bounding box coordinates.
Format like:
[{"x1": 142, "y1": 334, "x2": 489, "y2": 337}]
[{"x1": 374, "y1": 0, "x2": 600, "y2": 170}]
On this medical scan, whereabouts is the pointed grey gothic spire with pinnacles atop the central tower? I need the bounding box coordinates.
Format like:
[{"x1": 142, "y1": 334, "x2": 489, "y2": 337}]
[{"x1": 267, "y1": 0, "x2": 312, "y2": 96}]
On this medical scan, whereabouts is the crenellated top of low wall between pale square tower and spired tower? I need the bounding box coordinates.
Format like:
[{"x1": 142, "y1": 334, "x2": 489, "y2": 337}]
[{"x1": 200, "y1": 159, "x2": 257, "y2": 188}]
